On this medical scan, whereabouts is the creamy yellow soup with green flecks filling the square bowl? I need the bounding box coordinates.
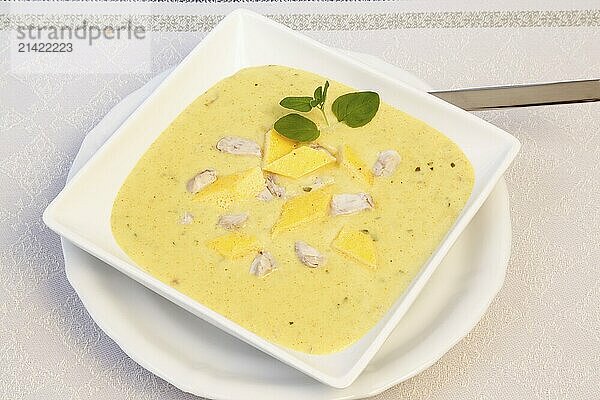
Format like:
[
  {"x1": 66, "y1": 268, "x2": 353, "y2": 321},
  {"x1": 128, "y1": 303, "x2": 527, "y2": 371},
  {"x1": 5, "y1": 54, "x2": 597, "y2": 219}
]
[{"x1": 111, "y1": 66, "x2": 474, "y2": 354}]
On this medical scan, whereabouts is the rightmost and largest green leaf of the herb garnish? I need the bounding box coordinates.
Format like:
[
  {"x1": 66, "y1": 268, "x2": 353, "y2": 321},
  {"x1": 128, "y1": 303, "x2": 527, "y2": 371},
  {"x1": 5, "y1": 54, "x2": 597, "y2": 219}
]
[{"x1": 331, "y1": 92, "x2": 379, "y2": 128}]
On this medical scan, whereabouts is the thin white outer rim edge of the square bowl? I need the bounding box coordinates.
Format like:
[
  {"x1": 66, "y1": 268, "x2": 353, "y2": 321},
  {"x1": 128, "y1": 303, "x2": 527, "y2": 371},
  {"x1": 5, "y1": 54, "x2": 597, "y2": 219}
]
[{"x1": 43, "y1": 9, "x2": 520, "y2": 388}]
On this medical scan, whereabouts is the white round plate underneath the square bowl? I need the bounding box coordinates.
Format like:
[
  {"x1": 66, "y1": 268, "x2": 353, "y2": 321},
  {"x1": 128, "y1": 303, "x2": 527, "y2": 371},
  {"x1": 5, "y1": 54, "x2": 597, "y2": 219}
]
[{"x1": 63, "y1": 53, "x2": 511, "y2": 400}]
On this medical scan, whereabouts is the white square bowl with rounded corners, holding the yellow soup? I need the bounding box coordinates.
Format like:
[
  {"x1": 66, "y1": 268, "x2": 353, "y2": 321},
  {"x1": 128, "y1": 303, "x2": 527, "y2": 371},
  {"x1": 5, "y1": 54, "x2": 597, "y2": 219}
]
[{"x1": 44, "y1": 10, "x2": 520, "y2": 388}]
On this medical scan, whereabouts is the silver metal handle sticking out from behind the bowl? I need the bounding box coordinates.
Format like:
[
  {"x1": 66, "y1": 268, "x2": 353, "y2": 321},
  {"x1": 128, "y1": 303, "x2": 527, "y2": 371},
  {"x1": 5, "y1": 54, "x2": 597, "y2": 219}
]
[{"x1": 429, "y1": 79, "x2": 600, "y2": 111}]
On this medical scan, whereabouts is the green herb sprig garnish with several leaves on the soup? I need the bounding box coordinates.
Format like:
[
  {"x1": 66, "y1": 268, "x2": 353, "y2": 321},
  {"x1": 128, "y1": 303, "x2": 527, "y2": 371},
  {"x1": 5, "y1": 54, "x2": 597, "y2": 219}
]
[{"x1": 273, "y1": 81, "x2": 379, "y2": 142}]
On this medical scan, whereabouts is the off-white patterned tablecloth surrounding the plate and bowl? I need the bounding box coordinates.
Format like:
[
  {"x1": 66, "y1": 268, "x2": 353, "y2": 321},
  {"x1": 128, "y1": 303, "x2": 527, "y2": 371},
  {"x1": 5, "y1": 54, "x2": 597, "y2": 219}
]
[{"x1": 0, "y1": 1, "x2": 600, "y2": 400}]
